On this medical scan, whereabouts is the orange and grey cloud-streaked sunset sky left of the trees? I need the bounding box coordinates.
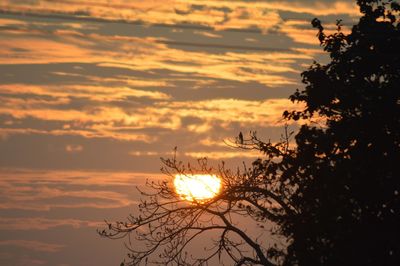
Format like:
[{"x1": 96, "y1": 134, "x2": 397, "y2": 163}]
[{"x1": 0, "y1": 0, "x2": 359, "y2": 266}]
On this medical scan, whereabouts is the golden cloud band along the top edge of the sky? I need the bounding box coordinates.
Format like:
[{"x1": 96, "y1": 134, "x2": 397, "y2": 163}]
[{"x1": 3, "y1": 0, "x2": 359, "y2": 28}]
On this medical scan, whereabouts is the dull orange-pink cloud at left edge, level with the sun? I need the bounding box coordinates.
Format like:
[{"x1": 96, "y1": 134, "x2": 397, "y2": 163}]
[{"x1": 0, "y1": 170, "x2": 155, "y2": 211}]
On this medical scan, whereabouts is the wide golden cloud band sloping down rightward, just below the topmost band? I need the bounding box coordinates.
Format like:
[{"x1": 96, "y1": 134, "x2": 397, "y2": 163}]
[{"x1": 0, "y1": 26, "x2": 299, "y2": 86}]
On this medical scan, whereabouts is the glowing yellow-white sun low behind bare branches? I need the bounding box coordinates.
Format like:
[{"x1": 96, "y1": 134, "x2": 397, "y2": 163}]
[{"x1": 174, "y1": 174, "x2": 221, "y2": 201}]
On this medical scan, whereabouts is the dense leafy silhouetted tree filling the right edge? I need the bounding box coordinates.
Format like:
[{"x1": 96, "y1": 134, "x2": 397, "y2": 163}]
[{"x1": 281, "y1": 0, "x2": 400, "y2": 265}]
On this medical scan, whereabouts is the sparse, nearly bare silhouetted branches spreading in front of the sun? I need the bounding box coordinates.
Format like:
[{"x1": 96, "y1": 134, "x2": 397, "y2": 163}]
[{"x1": 99, "y1": 137, "x2": 295, "y2": 265}]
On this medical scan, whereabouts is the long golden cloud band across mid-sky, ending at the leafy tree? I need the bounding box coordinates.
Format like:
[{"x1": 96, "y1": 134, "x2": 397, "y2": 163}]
[{"x1": 0, "y1": 94, "x2": 300, "y2": 143}]
